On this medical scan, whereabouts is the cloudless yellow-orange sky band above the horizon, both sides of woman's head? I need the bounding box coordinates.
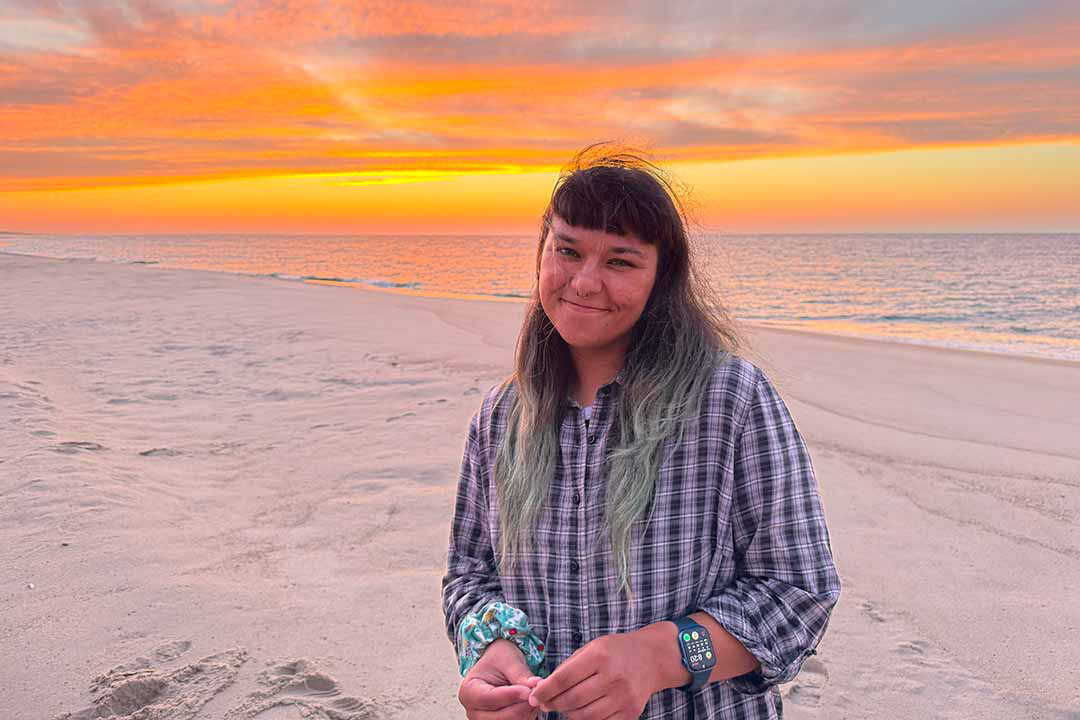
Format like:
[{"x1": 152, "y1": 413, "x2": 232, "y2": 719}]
[{"x1": 0, "y1": 142, "x2": 1080, "y2": 234}]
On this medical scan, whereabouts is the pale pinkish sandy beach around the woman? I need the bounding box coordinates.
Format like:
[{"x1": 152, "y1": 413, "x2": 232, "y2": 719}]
[{"x1": 0, "y1": 250, "x2": 1080, "y2": 720}]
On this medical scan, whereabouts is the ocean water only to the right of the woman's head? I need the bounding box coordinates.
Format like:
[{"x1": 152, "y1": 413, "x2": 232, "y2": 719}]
[{"x1": 702, "y1": 234, "x2": 1080, "y2": 359}]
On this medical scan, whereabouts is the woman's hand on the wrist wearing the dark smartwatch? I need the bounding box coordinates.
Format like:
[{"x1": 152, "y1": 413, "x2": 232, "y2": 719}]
[{"x1": 529, "y1": 633, "x2": 662, "y2": 720}]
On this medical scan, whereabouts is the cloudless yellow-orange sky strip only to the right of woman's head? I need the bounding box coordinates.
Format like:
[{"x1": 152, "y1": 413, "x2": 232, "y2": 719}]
[{"x1": 673, "y1": 142, "x2": 1080, "y2": 232}]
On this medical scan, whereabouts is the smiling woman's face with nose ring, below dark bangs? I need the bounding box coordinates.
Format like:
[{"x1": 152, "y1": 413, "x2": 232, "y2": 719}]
[{"x1": 539, "y1": 215, "x2": 657, "y2": 352}]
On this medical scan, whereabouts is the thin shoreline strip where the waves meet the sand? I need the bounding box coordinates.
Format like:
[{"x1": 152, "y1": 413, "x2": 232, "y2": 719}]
[{"x1": 0, "y1": 246, "x2": 1080, "y2": 367}]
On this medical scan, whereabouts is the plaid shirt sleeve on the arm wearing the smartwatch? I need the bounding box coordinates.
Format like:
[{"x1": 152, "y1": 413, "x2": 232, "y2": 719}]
[{"x1": 701, "y1": 370, "x2": 840, "y2": 693}]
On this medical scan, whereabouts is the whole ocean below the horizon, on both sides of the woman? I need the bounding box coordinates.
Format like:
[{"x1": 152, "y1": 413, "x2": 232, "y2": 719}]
[{"x1": 0, "y1": 233, "x2": 1080, "y2": 362}]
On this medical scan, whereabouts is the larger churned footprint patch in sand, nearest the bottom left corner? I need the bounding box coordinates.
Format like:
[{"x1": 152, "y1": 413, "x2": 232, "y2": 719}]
[{"x1": 56, "y1": 641, "x2": 247, "y2": 720}]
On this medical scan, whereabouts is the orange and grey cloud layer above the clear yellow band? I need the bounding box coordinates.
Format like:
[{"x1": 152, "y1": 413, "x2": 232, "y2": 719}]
[{"x1": 0, "y1": 0, "x2": 1080, "y2": 190}]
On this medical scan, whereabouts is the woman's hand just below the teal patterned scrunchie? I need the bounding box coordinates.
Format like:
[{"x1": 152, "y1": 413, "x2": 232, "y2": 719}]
[{"x1": 458, "y1": 639, "x2": 540, "y2": 720}]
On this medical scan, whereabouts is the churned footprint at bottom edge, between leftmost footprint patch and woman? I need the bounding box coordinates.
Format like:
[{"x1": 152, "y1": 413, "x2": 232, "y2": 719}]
[{"x1": 225, "y1": 660, "x2": 388, "y2": 720}]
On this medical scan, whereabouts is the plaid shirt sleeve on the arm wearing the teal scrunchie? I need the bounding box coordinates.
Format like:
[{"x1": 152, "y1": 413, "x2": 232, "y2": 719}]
[{"x1": 443, "y1": 417, "x2": 503, "y2": 649}]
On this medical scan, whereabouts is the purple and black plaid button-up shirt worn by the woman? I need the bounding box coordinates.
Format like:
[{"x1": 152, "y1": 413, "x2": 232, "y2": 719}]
[{"x1": 443, "y1": 355, "x2": 840, "y2": 720}]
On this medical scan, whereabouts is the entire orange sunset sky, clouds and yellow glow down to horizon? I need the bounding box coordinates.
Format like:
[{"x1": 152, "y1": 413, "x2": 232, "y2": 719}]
[{"x1": 0, "y1": 0, "x2": 1080, "y2": 233}]
